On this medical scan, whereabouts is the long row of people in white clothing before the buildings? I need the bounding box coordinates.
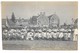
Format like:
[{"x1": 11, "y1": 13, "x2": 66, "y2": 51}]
[{"x1": 2, "y1": 28, "x2": 72, "y2": 41}]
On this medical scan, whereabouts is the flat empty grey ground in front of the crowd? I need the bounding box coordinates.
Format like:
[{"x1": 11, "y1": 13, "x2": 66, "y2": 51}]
[{"x1": 2, "y1": 40, "x2": 77, "y2": 50}]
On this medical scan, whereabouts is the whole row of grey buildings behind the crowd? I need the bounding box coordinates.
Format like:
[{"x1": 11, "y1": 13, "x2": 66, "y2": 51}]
[{"x1": 6, "y1": 12, "x2": 60, "y2": 28}]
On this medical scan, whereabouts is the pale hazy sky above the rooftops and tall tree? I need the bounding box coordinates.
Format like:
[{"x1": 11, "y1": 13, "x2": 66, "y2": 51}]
[{"x1": 1, "y1": 1, "x2": 78, "y2": 25}]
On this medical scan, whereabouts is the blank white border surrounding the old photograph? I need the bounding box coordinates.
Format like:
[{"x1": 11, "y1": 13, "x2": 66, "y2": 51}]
[{"x1": 0, "y1": 0, "x2": 80, "y2": 53}]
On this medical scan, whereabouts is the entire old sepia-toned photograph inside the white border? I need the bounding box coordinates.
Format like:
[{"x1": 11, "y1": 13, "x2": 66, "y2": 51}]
[{"x1": 1, "y1": 1, "x2": 78, "y2": 50}]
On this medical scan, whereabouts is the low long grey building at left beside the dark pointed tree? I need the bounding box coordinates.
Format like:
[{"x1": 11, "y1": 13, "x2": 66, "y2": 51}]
[{"x1": 6, "y1": 18, "x2": 28, "y2": 28}]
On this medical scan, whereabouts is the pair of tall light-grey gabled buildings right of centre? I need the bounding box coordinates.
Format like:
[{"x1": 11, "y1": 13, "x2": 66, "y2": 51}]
[{"x1": 37, "y1": 12, "x2": 60, "y2": 27}]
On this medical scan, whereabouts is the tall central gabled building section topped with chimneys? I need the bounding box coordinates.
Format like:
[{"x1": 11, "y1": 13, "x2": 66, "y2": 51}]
[{"x1": 37, "y1": 12, "x2": 49, "y2": 27}]
